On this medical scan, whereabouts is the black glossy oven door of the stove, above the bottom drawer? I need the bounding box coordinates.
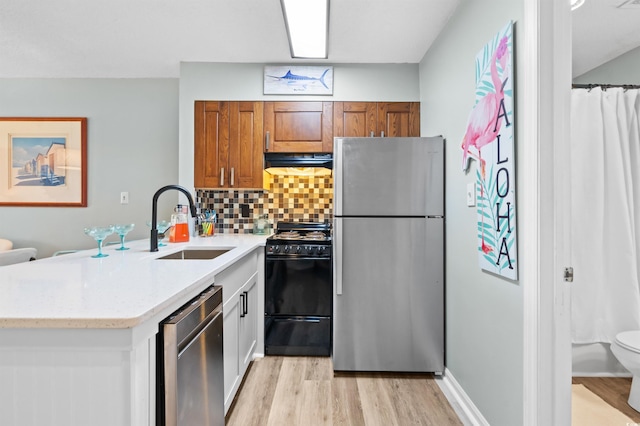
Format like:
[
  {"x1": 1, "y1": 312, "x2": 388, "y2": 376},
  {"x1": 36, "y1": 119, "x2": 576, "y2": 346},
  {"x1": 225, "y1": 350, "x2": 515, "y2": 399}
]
[{"x1": 265, "y1": 257, "x2": 333, "y2": 316}]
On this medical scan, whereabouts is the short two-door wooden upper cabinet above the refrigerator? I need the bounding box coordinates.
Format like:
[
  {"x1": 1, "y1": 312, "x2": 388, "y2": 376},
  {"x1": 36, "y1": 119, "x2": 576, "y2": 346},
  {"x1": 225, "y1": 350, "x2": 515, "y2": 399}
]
[{"x1": 333, "y1": 102, "x2": 420, "y2": 137}]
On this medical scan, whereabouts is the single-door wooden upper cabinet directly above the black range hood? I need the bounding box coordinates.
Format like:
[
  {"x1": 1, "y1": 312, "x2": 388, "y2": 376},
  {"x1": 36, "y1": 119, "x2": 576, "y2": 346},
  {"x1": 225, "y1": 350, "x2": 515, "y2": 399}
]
[{"x1": 264, "y1": 102, "x2": 333, "y2": 152}]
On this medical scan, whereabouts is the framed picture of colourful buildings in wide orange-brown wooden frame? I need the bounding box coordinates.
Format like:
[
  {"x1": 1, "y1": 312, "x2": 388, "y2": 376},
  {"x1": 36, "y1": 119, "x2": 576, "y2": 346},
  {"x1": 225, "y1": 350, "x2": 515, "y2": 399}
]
[{"x1": 0, "y1": 117, "x2": 87, "y2": 207}]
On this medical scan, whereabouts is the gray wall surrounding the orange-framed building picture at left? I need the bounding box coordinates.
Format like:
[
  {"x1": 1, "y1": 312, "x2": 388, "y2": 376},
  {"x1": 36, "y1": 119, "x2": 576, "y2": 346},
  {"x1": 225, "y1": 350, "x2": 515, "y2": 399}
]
[{"x1": 0, "y1": 79, "x2": 178, "y2": 257}]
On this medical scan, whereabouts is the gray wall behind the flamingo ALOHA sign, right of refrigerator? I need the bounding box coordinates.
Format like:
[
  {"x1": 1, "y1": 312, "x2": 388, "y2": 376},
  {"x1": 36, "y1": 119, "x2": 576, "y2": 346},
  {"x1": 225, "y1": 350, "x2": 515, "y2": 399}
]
[{"x1": 420, "y1": 0, "x2": 524, "y2": 426}]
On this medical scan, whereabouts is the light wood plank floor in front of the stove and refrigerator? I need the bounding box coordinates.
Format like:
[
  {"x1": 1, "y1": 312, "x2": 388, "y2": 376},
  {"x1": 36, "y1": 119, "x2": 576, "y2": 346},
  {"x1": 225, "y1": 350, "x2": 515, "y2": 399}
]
[{"x1": 226, "y1": 356, "x2": 462, "y2": 426}]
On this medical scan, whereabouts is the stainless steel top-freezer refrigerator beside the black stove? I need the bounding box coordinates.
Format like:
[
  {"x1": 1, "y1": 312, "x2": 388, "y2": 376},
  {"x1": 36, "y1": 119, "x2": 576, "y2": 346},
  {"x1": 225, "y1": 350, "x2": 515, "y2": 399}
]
[{"x1": 332, "y1": 137, "x2": 444, "y2": 373}]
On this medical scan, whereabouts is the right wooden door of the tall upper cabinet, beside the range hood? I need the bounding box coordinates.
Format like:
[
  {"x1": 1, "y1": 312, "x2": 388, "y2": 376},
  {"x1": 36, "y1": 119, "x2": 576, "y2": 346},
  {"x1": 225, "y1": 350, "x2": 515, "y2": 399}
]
[{"x1": 227, "y1": 102, "x2": 263, "y2": 188}]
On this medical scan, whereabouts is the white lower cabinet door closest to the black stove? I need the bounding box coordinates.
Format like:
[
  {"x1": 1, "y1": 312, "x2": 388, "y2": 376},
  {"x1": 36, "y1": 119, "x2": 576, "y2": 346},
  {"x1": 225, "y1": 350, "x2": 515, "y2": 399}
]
[{"x1": 240, "y1": 272, "x2": 258, "y2": 375}]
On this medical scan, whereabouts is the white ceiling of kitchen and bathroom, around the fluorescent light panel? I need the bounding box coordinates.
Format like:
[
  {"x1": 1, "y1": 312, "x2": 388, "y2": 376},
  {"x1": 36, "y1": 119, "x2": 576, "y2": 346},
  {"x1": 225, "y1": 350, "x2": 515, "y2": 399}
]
[{"x1": 0, "y1": 0, "x2": 640, "y2": 78}]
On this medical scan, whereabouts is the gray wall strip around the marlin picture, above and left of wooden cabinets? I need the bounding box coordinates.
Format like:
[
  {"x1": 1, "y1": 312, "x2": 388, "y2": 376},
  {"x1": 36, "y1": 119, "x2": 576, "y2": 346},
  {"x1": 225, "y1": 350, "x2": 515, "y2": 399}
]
[{"x1": 179, "y1": 62, "x2": 419, "y2": 188}]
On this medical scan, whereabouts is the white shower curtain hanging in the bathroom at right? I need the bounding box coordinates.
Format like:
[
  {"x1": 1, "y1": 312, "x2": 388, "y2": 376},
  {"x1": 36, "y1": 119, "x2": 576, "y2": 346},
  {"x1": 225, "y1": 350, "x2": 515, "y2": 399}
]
[{"x1": 570, "y1": 87, "x2": 640, "y2": 343}]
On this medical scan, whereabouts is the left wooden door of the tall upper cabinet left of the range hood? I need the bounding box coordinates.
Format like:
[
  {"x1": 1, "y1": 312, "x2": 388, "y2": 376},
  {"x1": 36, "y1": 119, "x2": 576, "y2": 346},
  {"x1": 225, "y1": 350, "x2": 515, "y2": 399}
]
[{"x1": 193, "y1": 101, "x2": 229, "y2": 188}]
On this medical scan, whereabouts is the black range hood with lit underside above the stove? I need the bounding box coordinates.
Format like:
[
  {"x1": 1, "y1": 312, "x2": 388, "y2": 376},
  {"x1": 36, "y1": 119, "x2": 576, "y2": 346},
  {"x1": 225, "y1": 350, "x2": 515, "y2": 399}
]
[{"x1": 264, "y1": 152, "x2": 333, "y2": 176}]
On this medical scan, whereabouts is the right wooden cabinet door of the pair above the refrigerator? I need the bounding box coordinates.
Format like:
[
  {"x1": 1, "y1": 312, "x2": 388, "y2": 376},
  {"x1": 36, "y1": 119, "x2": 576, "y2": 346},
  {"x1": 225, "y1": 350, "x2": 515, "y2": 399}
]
[{"x1": 376, "y1": 102, "x2": 420, "y2": 137}]
